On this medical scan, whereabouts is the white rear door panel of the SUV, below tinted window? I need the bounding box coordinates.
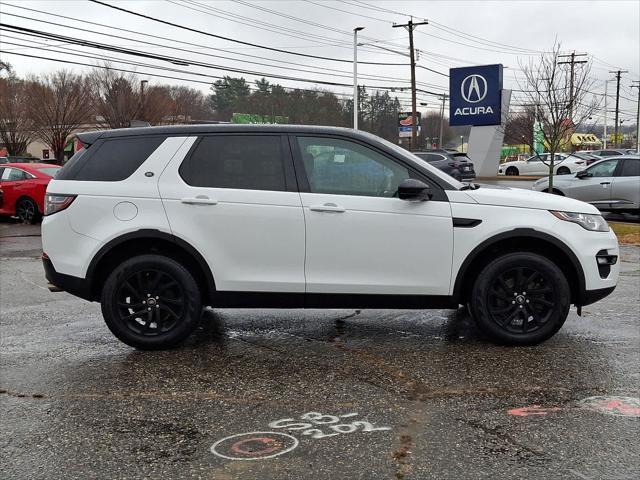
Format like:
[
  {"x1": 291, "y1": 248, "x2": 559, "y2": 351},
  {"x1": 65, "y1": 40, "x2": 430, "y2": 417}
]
[{"x1": 158, "y1": 137, "x2": 305, "y2": 293}]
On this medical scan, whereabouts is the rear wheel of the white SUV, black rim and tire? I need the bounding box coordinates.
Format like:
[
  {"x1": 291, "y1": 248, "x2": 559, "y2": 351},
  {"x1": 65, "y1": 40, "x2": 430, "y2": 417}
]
[{"x1": 101, "y1": 255, "x2": 202, "y2": 350}]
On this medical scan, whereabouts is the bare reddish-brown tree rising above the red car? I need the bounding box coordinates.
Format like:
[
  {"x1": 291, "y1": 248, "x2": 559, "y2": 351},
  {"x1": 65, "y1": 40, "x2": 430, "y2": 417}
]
[{"x1": 27, "y1": 70, "x2": 93, "y2": 163}]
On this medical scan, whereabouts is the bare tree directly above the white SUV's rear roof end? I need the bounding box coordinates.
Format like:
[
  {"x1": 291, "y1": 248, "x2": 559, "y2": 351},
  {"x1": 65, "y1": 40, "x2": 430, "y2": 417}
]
[{"x1": 89, "y1": 64, "x2": 142, "y2": 128}]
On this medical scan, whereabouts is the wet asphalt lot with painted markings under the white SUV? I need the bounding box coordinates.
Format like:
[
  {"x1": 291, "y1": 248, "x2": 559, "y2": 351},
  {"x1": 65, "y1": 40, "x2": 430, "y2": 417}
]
[{"x1": 0, "y1": 222, "x2": 640, "y2": 480}]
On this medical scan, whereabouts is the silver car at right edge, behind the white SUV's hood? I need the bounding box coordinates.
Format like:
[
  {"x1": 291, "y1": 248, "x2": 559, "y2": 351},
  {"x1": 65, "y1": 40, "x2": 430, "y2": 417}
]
[{"x1": 531, "y1": 155, "x2": 640, "y2": 214}]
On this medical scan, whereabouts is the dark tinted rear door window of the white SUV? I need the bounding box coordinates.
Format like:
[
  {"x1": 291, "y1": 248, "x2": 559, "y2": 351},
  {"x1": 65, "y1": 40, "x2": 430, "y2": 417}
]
[{"x1": 179, "y1": 135, "x2": 286, "y2": 191}]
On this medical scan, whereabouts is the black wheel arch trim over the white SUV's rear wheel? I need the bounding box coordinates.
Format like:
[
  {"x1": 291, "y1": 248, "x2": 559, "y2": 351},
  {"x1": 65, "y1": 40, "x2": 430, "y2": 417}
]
[{"x1": 85, "y1": 229, "x2": 215, "y2": 305}]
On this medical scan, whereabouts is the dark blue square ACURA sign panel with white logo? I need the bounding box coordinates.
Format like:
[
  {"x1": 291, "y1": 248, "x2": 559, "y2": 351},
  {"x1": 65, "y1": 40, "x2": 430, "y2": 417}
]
[{"x1": 449, "y1": 65, "x2": 502, "y2": 126}]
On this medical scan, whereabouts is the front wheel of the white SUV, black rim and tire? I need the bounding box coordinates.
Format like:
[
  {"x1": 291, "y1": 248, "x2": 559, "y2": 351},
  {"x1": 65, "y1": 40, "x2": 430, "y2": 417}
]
[{"x1": 470, "y1": 252, "x2": 570, "y2": 345}]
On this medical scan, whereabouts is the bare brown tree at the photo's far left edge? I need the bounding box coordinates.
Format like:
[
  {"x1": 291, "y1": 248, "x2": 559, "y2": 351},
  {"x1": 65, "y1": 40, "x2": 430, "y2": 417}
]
[{"x1": 0, "y1": 72, "x2": 34, "y2": 155}]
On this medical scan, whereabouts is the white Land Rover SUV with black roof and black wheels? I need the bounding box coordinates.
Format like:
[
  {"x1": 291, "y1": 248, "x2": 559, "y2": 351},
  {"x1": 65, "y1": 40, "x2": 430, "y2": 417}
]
[{"x1": 42, "y1": 125, "x2": 619, "y2": 349}]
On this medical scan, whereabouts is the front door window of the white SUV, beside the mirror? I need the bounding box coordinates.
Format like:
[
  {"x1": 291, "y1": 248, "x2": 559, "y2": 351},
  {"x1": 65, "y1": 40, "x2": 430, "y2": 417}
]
[{"x1": 297, "y1": 137, "x2": 409, "y2": 197}]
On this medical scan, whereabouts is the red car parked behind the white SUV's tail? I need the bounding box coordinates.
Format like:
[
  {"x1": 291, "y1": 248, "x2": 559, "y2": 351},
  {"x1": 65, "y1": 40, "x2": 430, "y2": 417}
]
[{"x1": 0, "y1": 163, "x2": 60, "y2": 223}]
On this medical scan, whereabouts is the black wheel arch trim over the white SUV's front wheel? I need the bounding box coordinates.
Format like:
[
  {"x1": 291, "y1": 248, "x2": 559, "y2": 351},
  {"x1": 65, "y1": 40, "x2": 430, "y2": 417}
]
[{"x1": 453, "y1": 228, "x2": 586, "y2": 304}]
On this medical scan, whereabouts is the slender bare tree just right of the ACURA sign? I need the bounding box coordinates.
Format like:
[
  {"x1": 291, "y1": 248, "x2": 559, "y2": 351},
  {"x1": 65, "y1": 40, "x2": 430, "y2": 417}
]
[{"x1": 520, "y1": 43, "x2": 599, "y2": 192}]
